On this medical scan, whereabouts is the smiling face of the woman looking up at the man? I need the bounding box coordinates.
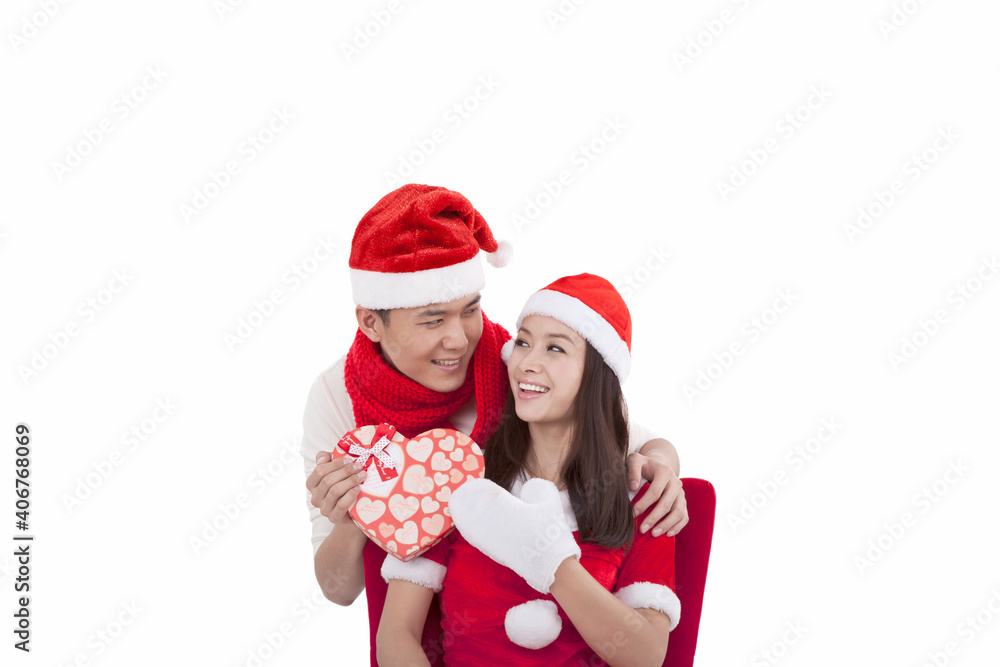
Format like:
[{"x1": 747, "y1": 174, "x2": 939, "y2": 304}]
[{"x1": 507, "y1": 315, "x2": 587, "y2": 425}]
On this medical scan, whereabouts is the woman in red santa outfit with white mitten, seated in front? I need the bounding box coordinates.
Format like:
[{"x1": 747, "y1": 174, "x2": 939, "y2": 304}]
[{"x1": 378, "y1": 274, "x2": 680, "y2": 667}]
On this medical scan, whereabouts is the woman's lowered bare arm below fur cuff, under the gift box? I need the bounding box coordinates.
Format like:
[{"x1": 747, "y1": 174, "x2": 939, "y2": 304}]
[{"x1": 375, "y1": 580, "x2": 434, "y2": 667}]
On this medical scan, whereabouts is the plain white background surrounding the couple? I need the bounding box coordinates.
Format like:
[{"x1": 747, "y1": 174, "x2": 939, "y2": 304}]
[{"x1": 0, "y1": 0, "x2": 1000, "y2": 666}]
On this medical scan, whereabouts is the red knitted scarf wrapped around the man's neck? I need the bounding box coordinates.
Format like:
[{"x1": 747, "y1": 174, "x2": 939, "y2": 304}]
[{"x1": 344, "y1": 313, "x2": 510, "y2": 444}]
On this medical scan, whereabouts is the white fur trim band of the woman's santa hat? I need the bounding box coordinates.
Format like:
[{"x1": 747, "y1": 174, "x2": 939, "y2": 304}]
[{"x1": 504, "y1": 290, "x2": 632, "y2": 382}]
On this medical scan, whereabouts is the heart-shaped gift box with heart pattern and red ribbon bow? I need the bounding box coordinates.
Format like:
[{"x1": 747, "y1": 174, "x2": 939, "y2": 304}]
[{"x1": 333, "y1": 424, "x2": 486, "y2": 562}]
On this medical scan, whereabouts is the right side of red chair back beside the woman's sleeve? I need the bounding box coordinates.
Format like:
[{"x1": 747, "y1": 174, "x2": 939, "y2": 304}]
[{"x1": 663, "y1": 477, "x2": 715, "y2": 667}]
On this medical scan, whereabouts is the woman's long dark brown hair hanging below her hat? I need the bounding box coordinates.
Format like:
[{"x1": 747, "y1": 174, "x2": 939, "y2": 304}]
[{"x1": 483, "y1": 343, "x2": 634, "y2": 549}]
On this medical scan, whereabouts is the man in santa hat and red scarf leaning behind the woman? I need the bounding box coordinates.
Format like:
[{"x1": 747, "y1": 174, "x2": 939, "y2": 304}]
[{"x1": 302, "y1": 184, "x2": 687, "y2": 667}]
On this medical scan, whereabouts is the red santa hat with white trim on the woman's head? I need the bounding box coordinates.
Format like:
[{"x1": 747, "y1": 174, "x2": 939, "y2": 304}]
[{"x1": 502, "y1": 273, "x2": 632, "y2": 382}]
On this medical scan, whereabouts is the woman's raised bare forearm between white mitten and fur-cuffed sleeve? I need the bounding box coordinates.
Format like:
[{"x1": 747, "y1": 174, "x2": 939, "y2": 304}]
[{"x1": 548, "y1": 558, "x2": 670, "y2": 667}]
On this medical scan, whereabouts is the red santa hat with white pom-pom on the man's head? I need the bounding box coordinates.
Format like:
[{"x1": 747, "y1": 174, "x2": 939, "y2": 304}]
[{"x1": 349, "y1": 183, "x2": 511, "y2": 309}]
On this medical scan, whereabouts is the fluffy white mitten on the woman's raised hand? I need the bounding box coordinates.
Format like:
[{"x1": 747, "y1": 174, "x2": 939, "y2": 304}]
[{"x1": 448, "y1": 479, "x2": 580, "y2": 593}]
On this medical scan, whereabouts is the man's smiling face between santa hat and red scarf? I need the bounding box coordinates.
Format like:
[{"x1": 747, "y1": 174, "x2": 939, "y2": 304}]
[{"x1": 373, "y1": 293, "x2": 483, "y2": 393}]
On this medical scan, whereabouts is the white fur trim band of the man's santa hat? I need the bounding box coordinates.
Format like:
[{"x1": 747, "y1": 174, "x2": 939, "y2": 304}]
[{"x1": 351, "y1": 255, "x2": 486, "y2": 310}]
